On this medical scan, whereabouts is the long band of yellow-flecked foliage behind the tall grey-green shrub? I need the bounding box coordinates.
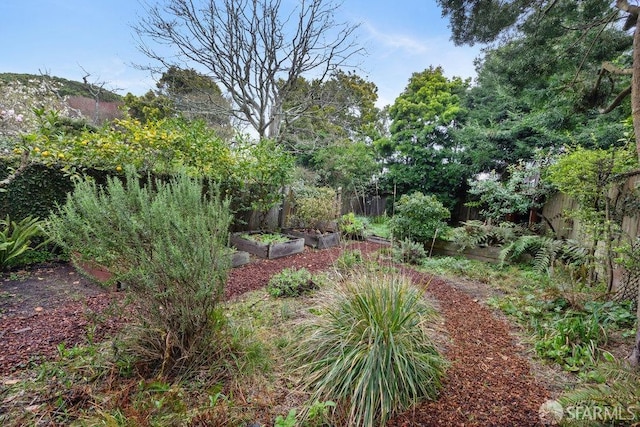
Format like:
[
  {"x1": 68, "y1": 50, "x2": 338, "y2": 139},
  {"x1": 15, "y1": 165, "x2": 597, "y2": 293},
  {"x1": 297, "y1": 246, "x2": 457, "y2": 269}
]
[{"x1": 15, "y1": 115, "x2": 232, "y2": 178}]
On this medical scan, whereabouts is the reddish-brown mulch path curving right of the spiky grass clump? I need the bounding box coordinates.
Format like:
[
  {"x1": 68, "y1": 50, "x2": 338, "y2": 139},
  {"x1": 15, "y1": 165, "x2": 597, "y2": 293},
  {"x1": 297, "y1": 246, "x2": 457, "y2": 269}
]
[{"x1": 390, "y1": 272, "x2": 549, "y2": 427}]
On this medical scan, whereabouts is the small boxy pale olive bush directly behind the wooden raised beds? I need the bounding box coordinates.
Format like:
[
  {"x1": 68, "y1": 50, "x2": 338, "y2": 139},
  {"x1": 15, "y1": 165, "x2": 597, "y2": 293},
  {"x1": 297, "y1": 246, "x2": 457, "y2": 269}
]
[{"x1": 291, "y1": 187, "x2": 338, "y2": 231}]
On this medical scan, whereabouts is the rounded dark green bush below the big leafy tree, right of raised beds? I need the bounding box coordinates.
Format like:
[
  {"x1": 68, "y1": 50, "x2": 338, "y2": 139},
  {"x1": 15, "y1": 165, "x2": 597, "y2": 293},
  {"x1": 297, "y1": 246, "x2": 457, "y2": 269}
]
[{"x1": 389, "y1": 192, "x2": 451, "y2": 243}]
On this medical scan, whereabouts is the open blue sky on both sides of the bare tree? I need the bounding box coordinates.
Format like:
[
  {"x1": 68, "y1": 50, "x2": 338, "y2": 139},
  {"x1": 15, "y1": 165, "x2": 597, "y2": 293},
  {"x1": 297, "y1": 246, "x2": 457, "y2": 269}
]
[{"x1": 0, "y1": 0, "x2": 480, "y2": 106}]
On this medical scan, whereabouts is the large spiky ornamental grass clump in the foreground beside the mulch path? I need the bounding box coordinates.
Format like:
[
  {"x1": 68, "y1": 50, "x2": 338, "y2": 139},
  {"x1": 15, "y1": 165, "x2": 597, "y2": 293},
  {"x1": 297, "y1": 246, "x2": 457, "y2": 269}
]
[{"x1": 295, "y1": 272, "x2": 446, "y2": 426}]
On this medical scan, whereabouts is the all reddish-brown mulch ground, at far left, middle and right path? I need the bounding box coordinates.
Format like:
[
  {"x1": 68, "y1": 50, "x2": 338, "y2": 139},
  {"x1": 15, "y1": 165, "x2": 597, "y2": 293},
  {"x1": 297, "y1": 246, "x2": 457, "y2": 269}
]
[{"x1": 0, "y1": 242, "x2": 549, "y2": 427}]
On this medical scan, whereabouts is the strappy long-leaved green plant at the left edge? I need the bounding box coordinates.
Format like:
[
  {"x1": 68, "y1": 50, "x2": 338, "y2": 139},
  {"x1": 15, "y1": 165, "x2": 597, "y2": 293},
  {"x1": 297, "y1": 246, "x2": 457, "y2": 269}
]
[{"x1": 0, "y1": 215, "x2": 46, "y2": 270}]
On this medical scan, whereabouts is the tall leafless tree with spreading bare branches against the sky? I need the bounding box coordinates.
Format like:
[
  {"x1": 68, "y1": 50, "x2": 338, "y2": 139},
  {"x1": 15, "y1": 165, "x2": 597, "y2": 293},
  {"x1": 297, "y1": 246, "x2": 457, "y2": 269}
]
[{"x1": 134, "y1": 0, "x2": 362, "y2": 138}]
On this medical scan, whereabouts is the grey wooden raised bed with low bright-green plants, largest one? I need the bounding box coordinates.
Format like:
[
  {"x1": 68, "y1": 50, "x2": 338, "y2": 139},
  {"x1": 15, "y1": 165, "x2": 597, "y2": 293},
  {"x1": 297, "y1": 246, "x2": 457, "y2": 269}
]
[{"x1": 229, "y1": 231, "x2": 304, "y2": 259}]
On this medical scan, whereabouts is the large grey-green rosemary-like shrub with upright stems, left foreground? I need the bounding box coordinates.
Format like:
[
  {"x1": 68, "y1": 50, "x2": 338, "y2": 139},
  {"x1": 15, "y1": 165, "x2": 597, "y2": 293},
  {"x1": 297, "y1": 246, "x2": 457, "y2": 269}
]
[{"x1": 49, "y1": 170, "x2": 231, "y2": 375}]
